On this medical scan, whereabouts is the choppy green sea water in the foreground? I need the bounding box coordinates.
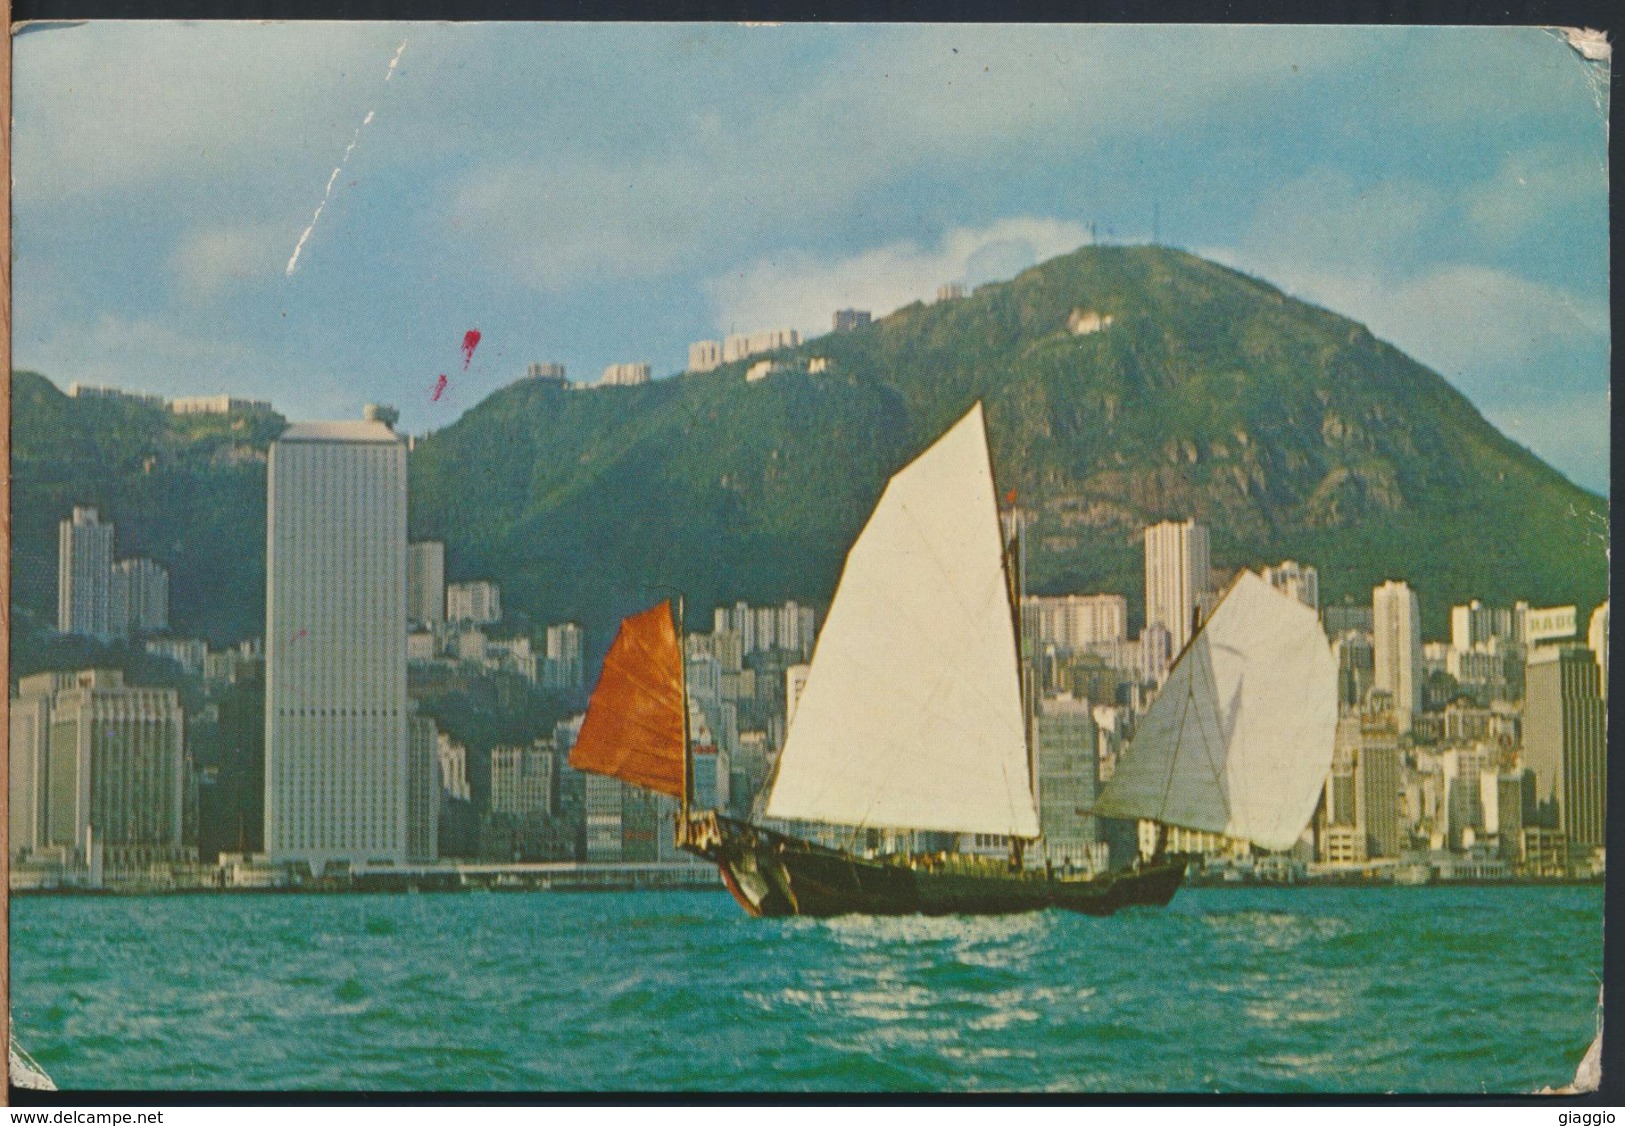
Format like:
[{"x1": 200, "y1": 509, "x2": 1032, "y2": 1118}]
[{"x1": 11, "y1": 887, "x2": 1602, "y2": 1094}]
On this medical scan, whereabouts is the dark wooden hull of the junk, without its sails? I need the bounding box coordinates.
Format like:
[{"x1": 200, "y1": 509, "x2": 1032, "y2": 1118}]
[{"x1": 679, "y1": 814, "x2": 1186, "y2": 918}]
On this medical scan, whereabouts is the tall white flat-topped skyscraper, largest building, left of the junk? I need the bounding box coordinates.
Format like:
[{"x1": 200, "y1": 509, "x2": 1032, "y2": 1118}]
[{"x1": 265, "y1": 421, "x2": 408, "y2": 869}]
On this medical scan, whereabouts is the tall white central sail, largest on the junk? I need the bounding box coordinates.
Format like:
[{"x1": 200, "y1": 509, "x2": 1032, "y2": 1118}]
[{"x1": 767, "y1": 403, "x2": 1038, "y2": 837}]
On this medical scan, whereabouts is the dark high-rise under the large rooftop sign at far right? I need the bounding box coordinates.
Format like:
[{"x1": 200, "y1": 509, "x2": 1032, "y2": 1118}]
[{"x1": 1523, "y1": 645, "x2": 1609, "y2": 848}]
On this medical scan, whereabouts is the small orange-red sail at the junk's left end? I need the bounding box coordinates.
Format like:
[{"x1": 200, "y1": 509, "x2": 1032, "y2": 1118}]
[{"x1": 570, "y1": 603, "x2": 684, "y2": 798}]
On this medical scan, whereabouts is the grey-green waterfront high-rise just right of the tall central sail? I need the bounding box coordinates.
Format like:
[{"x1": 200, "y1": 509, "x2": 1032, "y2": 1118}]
[{"x1": 1037, "y1": 695, "x2": 1100, "y2": 866}]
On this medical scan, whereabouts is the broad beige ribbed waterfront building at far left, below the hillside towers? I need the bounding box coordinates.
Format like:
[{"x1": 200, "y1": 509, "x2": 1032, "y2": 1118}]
[{"x1": 31, "y1": 669, "x2": 185, "y2": 868}]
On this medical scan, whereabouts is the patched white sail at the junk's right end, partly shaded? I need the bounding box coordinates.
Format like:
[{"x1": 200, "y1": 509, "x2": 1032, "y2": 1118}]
[{"x1": 1095, "y1": 570, "x2": 1337, "y2": 850}]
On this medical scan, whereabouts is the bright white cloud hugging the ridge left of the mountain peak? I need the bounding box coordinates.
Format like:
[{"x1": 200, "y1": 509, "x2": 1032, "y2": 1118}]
[{"x1": 705, "y1": 218, "x2": 1089, "y2": 335}]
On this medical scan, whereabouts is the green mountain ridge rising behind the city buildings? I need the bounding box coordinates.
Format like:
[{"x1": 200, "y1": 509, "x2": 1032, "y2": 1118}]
[{"x1": 13, "y1": 247, "x2": 1607, "y2": 666}]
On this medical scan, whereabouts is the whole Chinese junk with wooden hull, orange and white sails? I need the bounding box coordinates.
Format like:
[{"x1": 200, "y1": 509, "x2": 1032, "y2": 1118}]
[{"x1": 570, "y1": 403, "x2": 1337, "y2": 916}]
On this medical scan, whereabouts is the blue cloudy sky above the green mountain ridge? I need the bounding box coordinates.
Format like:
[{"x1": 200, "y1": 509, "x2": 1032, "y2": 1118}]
[{"x1": 13, "y1": 23, "x2": 1609, "y2": 491}]
